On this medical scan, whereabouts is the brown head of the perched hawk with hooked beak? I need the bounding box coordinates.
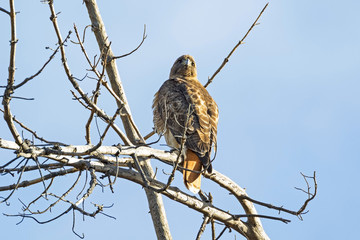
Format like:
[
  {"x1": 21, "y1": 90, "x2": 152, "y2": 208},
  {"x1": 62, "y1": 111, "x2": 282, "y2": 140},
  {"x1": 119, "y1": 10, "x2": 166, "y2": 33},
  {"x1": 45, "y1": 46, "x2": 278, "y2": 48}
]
[{"x1": 170, "y1": 55, "x2": 197, "y2": 79}]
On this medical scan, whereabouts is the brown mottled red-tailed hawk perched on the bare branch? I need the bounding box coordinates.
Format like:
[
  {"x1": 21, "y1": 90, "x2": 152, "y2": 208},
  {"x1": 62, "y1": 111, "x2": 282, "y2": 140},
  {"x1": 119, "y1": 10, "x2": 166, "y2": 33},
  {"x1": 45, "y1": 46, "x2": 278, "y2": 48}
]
[{"x1": 152, "y1": 55, "x2": 219, "y2": 193}]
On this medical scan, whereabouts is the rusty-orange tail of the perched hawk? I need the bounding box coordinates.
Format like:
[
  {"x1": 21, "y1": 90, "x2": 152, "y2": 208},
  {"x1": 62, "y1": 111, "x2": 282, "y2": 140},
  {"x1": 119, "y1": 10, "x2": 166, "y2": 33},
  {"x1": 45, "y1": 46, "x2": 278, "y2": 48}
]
[{"x1": 183, "y1": 149, "x2": 202, "y2": 194}]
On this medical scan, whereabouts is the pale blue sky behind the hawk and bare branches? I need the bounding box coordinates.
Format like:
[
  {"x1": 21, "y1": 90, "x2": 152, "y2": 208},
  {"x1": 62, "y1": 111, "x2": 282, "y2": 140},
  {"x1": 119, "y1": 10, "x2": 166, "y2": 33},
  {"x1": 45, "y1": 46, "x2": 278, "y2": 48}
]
[{"x1": 0, "y1": 0, "x2": 360, "y2": 240}]
